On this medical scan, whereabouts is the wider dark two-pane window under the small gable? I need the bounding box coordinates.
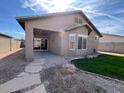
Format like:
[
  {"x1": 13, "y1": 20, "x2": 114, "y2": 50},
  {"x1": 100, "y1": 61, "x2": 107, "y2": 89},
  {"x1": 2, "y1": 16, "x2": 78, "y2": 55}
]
[{"x1": 78, "y1": 35, "x2": 86, "y2": 49}]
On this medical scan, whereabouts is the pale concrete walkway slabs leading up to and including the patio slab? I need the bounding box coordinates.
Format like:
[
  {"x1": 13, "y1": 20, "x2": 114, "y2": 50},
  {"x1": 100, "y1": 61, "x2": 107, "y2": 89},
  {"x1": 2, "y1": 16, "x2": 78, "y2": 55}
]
[{"x1": 0, "y1": 51, "x2": 67, "y2": 93}]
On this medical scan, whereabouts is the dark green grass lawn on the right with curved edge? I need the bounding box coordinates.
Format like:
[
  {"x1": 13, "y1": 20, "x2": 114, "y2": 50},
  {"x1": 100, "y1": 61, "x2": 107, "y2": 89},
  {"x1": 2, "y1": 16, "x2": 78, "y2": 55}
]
[{"x1": 72, "y1": 54, "x2": 124, "y2": 80}]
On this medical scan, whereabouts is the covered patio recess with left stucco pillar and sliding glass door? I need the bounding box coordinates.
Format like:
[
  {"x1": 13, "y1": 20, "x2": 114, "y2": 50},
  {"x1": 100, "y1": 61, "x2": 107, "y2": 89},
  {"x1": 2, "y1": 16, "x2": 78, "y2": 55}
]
[{"x1": 25, "y1": 28, "x2": 61, "y2": 61}]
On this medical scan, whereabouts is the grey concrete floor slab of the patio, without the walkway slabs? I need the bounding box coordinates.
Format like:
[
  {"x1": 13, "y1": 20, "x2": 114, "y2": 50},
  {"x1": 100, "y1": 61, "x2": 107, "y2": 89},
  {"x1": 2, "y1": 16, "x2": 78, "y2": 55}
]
[{"x1": 34, "y1": 51, "x2": 68, "y2": 69}]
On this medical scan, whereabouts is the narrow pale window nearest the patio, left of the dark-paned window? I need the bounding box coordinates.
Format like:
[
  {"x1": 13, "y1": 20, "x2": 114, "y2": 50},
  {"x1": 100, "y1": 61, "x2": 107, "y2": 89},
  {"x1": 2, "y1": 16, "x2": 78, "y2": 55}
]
[{"x1": 69, "y1": 34, "x2": 76, "y2": 50}]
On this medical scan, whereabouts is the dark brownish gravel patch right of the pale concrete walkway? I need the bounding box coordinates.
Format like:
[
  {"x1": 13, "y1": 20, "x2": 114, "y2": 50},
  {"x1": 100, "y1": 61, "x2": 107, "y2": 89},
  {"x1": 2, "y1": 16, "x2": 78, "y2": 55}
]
[{"x1": 40, "y1": 67, "x2": 106, "y2": 93}]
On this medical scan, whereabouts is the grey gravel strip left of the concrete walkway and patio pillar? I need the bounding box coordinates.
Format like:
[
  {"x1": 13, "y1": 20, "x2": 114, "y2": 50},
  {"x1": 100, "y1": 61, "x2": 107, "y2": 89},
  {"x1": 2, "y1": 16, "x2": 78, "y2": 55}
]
[{"x1": 0, "y1": 50, "x2": 29, "y2": 84}]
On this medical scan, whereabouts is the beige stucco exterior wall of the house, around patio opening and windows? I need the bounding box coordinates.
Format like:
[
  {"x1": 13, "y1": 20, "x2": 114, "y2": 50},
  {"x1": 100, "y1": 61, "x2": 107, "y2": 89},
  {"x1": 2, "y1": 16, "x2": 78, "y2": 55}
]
[{"x1": 25, "y1": 13, "x2": 97, "y2": 60}]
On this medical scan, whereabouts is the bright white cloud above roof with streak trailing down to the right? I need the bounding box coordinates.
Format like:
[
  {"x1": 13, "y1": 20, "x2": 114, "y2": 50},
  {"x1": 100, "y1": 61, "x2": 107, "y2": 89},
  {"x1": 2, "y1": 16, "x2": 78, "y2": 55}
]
[{"x1": 22, "y1": 0, "x2": 124, "y2": 23}]
